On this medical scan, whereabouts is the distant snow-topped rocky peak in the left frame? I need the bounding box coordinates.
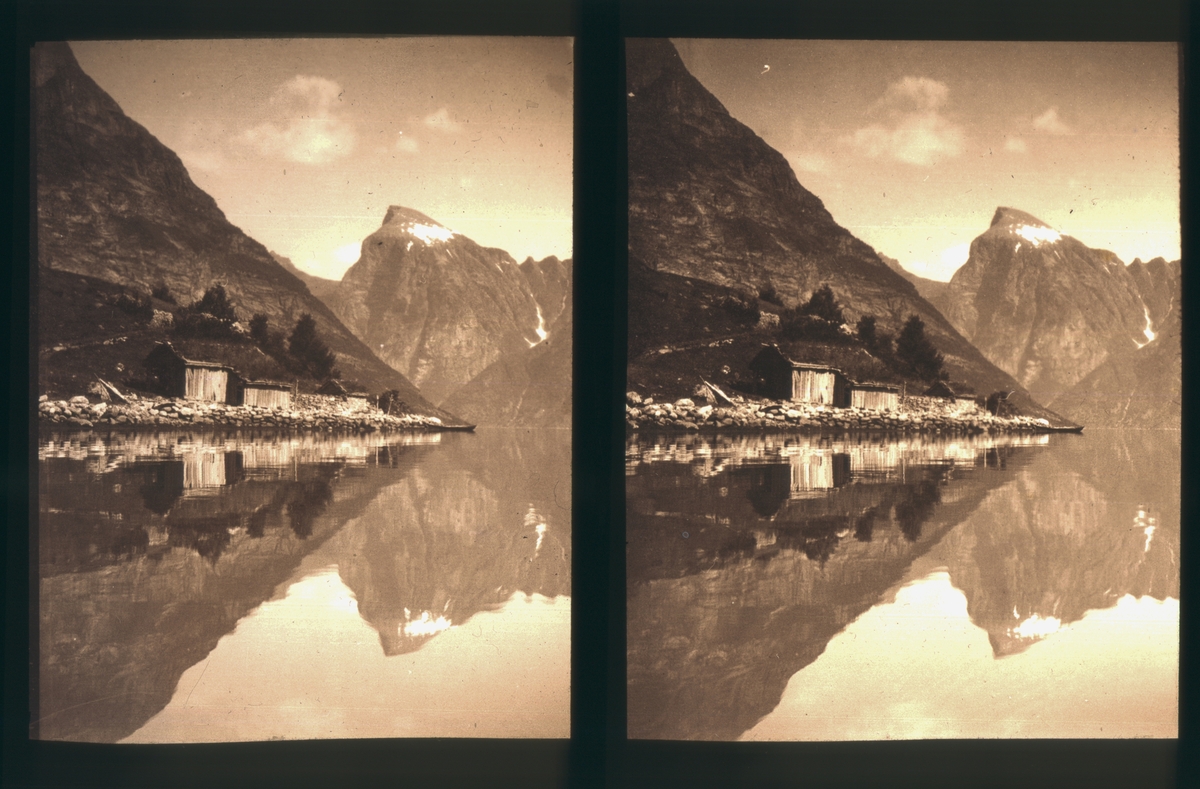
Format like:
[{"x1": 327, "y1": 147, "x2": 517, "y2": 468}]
[{"x1": 331, "y1": 205, "x2": 545, "y2": 402}]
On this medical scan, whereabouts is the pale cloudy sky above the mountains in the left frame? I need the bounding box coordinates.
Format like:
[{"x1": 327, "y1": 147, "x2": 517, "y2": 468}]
[{"x1": 71, "y1": 37, "x2": 574, "y2": 279}]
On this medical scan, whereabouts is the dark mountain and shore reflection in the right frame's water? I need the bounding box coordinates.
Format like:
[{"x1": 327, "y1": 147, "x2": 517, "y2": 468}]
[{"x1": 626, "y1": 426, "x2": 1178, "y2": 740}]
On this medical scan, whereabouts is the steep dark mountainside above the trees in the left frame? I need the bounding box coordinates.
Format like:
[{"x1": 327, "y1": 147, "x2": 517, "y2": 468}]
[{"x1": 32, "y1": 42, "x2": 448, "y2": 416}]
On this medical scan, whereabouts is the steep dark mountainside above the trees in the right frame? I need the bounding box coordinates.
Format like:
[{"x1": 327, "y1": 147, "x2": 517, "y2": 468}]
[{"x1": 626, "y1": 38, "x2": 1060, "y2": 418}]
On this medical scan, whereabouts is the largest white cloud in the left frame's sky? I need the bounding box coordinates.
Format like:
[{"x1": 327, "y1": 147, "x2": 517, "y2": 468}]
[{"x1": 239, "y1": 74, "x2": 356, "y2": 164}]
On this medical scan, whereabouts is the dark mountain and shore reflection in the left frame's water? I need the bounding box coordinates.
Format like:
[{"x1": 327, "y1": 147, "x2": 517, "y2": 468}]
[{"x1": 34, "y1": 430, "x2": 570, "y2": 741}]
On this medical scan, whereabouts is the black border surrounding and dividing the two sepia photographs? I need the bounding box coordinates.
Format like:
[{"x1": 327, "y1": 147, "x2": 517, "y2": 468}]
[{"x1": 0, "y1": 0, "x2": 1200, "y2": 789}]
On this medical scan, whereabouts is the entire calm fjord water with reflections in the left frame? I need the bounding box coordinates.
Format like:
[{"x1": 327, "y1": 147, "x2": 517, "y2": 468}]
[{"x1": 32, "y1": 429, "x2": 571, "y2": 742}]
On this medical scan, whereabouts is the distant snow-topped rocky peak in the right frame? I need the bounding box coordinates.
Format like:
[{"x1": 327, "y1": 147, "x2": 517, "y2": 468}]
[{"x1": 921, "y1": 207, "x2": 1178, "y2": 402}]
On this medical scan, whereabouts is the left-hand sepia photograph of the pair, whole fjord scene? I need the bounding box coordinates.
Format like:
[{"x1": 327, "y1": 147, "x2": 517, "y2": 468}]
[{"x1": 29, "y1": 37, "x2": 574, "y2": 743}]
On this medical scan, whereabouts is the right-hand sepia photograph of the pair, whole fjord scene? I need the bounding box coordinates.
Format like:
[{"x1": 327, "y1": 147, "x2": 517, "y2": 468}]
[{"x1": 624, "y1": 38, "x2": 1182, "y2": 742}]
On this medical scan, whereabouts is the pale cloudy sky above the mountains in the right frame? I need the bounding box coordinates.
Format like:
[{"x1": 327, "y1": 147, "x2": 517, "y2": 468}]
[{"x1": 674, "y1": 40, "x2": 1181, "y2": 281}]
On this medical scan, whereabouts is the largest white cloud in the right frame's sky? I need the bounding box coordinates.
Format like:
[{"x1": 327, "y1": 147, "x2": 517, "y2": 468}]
[{"x1": 848, "y1": 77, "x2": 964, "y2": 167}]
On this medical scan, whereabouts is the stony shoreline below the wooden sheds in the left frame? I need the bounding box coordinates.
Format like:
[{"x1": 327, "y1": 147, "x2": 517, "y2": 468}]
[{"x1": 37, "y1": 395, "x2": 445, "y2": 433}]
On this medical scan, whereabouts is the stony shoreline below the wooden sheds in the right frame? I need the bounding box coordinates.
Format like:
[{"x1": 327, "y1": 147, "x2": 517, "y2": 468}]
[{"x1": 625, "y1": 392, "x2": 1055, "y2": 433}]
